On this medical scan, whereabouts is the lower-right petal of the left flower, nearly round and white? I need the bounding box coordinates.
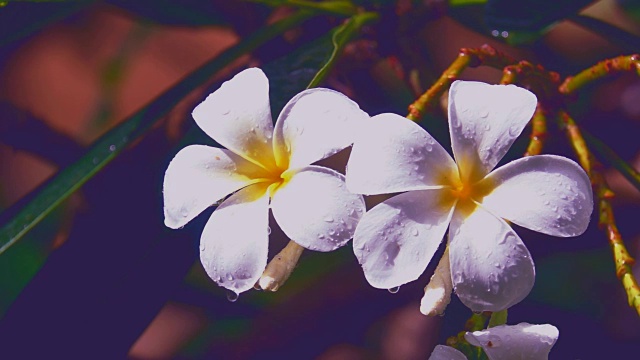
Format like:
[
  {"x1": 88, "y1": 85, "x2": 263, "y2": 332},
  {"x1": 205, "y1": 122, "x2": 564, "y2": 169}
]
[{"x1": 271, "y1": 165, "x2": 365, "y2": 251}]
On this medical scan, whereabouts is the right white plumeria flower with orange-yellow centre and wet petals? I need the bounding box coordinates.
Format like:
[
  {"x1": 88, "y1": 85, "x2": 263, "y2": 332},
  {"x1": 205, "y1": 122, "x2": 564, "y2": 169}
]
[{"x1": 347, "y1": 81, "x2": 593, "y2": 311}]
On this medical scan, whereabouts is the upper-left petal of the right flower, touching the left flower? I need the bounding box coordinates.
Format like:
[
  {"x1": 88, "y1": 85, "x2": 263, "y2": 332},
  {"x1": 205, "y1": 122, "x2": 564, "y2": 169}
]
[{"x1": 347, "y1": 114, "x2": 457, "y2": 195}]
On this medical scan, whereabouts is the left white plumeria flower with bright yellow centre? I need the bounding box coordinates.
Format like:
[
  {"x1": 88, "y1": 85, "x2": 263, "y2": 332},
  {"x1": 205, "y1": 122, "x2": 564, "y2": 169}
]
[{"x1": 164, "y1": 68, "x2": 369, "y2": 293}]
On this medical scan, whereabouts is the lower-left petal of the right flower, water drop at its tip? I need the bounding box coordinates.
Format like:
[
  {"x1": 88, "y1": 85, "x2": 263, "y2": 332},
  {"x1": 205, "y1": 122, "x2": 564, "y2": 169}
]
[{"x1": 353, "y1": 189, "x2": 453, "y2": 289}]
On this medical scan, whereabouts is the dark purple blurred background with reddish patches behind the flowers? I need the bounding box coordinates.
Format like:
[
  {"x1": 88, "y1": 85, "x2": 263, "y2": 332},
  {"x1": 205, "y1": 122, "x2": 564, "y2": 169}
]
[{"x1": 0, "y1": 0, "x2": 640, "y2": 360}]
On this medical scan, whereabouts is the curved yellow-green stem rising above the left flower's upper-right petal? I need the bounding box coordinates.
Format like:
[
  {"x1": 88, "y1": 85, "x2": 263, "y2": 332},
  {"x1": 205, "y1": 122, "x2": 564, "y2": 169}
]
[{"x1": 307, "y1": 12, "x2": 380, "y2": 89}]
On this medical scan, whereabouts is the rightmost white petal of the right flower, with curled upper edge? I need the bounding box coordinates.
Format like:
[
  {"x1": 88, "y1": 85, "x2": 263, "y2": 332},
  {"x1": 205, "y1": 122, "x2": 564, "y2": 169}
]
[{"x1": 482, "y1": 155, "x2": 593, "y2": 236}]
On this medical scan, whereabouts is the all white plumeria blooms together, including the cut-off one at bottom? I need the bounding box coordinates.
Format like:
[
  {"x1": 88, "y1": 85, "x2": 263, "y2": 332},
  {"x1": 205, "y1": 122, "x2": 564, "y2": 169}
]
[{"x1": 164, "y1": 68, "x2": 593, "y2": 359}]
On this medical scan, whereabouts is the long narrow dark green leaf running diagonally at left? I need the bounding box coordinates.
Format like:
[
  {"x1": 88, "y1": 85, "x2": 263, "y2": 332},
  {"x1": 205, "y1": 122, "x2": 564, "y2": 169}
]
[{"x1": 0, "y1": 11, "x2": 312, "y2": 254}]
